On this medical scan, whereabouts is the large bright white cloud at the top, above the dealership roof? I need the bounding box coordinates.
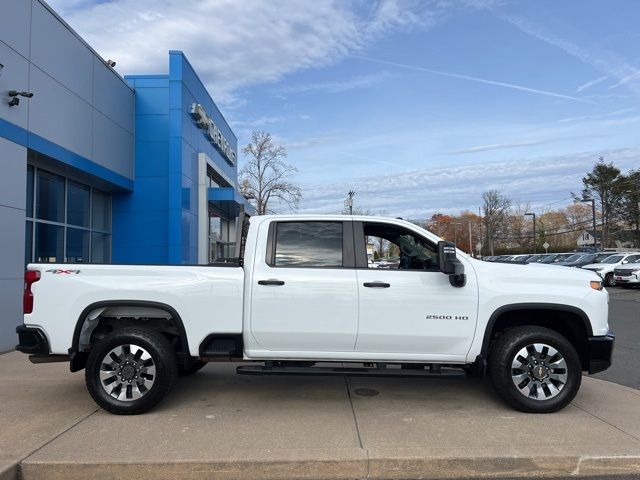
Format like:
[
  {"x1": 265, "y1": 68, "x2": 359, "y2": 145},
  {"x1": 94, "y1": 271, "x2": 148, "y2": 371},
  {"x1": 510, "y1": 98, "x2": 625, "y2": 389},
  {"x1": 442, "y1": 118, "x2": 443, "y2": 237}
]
[{"x1": 50, "y1": 0, "x2": 439, "y2": 105}]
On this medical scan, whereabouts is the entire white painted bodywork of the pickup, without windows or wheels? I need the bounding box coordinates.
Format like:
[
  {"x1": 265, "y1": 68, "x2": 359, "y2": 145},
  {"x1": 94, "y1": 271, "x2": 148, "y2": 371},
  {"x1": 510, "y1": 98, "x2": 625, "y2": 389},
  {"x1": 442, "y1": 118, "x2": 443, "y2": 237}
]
[{"x1": 24, "y1": 215, "x2": 609, "y2": 363}]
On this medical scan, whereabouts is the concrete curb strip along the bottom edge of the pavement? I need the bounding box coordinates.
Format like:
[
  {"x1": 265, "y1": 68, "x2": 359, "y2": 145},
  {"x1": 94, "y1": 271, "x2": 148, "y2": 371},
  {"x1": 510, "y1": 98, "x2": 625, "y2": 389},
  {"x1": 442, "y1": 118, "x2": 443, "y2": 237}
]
[{"x1": 15, "y1": 450, "x2": 640, "y2": 480}]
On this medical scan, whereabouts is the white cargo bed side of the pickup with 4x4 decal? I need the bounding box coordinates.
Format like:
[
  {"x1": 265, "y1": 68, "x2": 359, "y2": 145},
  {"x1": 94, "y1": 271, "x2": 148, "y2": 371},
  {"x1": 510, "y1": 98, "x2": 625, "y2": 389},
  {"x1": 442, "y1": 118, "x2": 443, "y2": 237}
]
[{"x1": 24, "y1": 264, "x2": 244, "y2": 357}]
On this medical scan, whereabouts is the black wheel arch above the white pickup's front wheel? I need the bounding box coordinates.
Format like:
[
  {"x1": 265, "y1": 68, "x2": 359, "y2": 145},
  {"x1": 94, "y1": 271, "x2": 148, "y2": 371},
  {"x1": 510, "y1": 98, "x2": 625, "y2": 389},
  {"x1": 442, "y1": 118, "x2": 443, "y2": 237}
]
[{"x1": 481, "y1": 303, "x2": 593, "y2": 370}]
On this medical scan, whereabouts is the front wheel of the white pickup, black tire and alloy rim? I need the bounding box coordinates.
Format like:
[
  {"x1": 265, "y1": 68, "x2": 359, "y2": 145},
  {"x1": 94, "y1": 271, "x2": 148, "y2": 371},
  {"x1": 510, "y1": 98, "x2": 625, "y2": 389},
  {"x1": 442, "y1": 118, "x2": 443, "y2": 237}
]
[{"x1": 489, "y1": 326, "x2": 582, "y2": 413}]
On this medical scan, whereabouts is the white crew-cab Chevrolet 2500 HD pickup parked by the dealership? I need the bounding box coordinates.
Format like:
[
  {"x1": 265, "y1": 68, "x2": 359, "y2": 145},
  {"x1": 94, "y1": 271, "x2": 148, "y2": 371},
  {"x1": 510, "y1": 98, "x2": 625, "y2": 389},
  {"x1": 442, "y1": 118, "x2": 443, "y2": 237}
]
[{"x1": 16, "y1": 215, "x2": 614, "y2": 414}]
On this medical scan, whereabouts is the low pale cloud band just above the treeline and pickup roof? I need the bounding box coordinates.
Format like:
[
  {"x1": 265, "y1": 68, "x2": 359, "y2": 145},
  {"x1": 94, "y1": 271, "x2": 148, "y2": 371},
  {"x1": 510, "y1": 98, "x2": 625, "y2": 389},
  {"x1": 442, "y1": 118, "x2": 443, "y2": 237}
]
[{"x1": 301, "y1": 149, "x2": 640, "y2": 220}]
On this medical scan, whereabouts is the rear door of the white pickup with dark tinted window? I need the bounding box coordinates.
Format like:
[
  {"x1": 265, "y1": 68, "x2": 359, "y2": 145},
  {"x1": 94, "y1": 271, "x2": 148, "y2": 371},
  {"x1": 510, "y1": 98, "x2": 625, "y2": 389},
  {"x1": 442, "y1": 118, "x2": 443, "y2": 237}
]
[{"x1": 250, "y1": 221, "x2": 358, "y2": 356}]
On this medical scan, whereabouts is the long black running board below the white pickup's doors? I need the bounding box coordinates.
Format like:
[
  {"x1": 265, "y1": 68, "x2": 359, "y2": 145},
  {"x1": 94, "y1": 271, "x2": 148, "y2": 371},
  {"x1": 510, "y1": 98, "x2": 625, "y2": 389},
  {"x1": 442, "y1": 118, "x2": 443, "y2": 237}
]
[{"x1": 236, "y1": 365, "x2": 466, "y2": 378}]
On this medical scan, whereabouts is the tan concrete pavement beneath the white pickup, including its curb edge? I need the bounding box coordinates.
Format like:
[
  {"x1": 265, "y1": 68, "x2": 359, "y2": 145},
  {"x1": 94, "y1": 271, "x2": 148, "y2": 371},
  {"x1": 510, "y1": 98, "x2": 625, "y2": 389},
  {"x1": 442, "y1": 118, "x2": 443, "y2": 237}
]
[{"x1": 0, "y1": 353, "x2": 640, "y2": 480}]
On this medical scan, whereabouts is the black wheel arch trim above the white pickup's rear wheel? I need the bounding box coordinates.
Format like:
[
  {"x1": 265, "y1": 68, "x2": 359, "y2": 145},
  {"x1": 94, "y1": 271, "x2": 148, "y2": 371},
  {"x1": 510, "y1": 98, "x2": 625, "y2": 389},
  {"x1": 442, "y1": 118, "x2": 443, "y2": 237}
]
[{"x1": 69, "y1": 300, "x2": 189, "y2": 372}]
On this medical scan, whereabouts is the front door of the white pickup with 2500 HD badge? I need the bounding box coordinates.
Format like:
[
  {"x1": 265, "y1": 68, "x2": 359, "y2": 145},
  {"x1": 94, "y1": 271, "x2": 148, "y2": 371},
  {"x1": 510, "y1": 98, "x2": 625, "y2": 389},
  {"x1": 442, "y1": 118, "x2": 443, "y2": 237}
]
[{"x1": 355, "y1": 222, "x2": 478, "y2": 361}]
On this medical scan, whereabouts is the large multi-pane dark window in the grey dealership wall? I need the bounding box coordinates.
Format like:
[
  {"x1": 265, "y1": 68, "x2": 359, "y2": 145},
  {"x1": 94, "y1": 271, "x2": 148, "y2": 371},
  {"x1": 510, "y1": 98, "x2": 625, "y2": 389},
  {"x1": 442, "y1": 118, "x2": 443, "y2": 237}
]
[{"x1": 25, "y1": 165, "x2": 111, "y2": 263}]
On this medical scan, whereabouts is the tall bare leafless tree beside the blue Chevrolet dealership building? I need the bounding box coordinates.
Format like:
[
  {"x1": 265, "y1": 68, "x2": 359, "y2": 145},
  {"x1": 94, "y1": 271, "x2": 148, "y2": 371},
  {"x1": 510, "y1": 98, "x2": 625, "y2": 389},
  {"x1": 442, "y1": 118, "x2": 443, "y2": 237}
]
[{"x1": 240, "y1": 131, "x2": 302, "y2": 215}]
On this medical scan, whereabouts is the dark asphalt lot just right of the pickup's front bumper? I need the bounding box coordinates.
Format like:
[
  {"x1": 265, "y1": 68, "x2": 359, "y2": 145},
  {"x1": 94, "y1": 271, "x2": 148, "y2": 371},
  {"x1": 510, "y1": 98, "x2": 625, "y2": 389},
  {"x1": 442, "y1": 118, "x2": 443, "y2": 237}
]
[{"x1": 594, "y1": 287, "x2": 640, "y2": 390}]
